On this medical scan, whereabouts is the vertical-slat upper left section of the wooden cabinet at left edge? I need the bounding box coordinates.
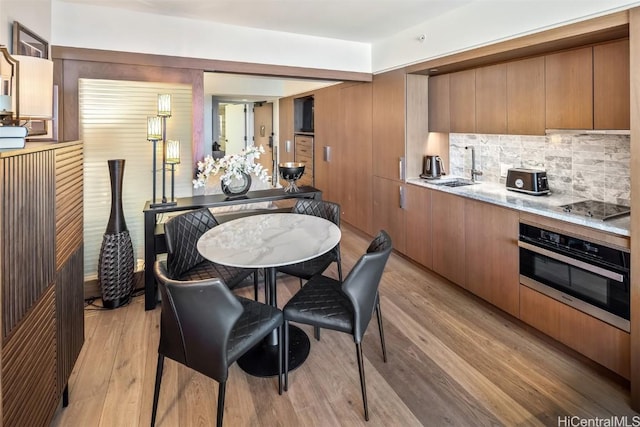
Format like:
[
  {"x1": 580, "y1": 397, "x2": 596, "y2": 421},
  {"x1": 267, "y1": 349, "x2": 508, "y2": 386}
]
[{"x1": 0, "y1": 150, "x2": 55, "y2": 338}]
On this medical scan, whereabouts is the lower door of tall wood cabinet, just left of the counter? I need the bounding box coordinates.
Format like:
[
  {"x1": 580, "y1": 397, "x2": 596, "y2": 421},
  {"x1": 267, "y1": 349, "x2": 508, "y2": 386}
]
[{"x1": 372, "y1": 176, "x2": 404, "y2": 253}]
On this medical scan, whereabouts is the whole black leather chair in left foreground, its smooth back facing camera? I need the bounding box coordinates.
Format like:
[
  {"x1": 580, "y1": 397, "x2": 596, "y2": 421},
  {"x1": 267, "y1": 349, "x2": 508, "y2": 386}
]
[{"x1": 151, "y1": 261, "x2": 283, "y2": 427}]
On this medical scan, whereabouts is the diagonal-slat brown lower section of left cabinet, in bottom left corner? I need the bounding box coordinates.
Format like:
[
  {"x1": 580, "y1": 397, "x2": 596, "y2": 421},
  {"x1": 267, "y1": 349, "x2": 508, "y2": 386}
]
[{"x1": 2, "y1": 286, "x2": 60, "y2": 426}]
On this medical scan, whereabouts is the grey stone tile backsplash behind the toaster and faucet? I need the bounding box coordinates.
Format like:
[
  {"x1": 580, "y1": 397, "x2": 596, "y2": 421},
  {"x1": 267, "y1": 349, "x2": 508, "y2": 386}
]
[{"x1": 449, "y1": 133, "x2": 631, "y2": 206}]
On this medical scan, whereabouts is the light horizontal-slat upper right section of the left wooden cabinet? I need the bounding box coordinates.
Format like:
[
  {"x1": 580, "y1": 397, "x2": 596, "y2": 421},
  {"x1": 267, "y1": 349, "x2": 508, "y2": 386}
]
[{"x1": 55, "y1": 145, "x2": 83, "y2": 270}]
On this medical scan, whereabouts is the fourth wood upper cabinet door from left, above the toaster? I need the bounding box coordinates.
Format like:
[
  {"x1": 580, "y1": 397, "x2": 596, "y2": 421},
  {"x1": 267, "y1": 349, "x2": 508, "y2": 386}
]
[{"x1": 507, "y1": 56, "x2": 545, "y2": 135}]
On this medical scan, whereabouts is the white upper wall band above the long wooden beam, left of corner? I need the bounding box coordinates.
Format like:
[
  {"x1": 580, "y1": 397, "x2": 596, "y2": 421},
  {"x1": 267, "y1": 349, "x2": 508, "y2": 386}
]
[{"x1": 52, "y1": 0, "x2": 371, "y2": 72}]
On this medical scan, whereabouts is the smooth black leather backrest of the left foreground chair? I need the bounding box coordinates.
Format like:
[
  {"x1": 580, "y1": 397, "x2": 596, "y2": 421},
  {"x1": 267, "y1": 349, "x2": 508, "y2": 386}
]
[{"x1": 154, "y1": 262, "x2": 243, "y2": 382}]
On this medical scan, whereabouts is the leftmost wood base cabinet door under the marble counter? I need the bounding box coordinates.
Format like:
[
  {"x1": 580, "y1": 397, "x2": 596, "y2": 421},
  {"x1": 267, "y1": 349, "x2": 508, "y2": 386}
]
[{"x1": 404, "y1": 185, "x2": 433, "y2": 269}]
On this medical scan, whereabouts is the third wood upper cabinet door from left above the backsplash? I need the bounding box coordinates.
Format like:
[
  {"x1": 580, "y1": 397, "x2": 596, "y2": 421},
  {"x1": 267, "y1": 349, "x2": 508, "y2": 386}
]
[{"x1": 476, "y1": 64, "x2": 507, "y2": 134}]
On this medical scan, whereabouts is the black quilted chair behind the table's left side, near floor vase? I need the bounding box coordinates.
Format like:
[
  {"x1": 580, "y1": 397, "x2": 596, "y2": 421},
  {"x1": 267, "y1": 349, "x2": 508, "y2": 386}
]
[{"x1": 164, "y1": 208, "x2": 258, "y2": 300}]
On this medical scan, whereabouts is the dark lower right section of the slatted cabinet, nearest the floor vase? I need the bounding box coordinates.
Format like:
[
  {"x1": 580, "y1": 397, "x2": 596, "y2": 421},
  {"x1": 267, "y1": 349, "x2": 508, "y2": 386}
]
[{"x1": 56, "y1": 247, "x2": 84, "y2": 394}]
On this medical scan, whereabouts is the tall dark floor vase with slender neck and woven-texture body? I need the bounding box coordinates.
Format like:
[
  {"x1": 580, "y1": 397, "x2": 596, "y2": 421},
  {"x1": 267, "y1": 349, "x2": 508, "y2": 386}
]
[{"x1": 98, "y1": 159, "x2": 135, "y2": 308}]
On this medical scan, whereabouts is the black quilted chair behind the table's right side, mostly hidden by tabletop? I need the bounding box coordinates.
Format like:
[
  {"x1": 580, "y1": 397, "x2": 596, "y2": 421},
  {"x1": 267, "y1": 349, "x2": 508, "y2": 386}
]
[{"x1": 278, "y1": 199, "x2": 342, "y2": 286}]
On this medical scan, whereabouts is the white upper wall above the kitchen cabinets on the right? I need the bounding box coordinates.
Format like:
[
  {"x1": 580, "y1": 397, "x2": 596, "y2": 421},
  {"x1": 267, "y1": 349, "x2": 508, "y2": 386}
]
[{"x1": 371, "y1": 0, "x2": 640, "y2": 73}]
